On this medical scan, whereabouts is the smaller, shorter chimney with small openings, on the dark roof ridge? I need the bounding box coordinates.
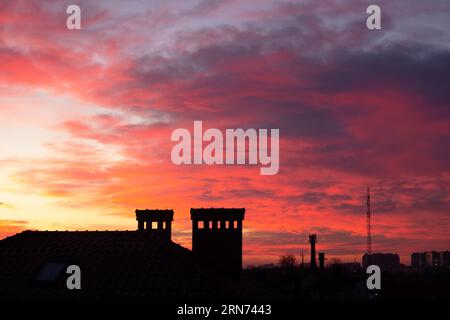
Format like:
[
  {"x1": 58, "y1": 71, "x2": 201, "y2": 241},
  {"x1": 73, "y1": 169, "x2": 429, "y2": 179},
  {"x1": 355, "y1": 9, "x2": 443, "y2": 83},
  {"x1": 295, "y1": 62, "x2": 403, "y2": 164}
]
[{"x1": 135, "y1": 209, "x2": 173, "y2": 241}]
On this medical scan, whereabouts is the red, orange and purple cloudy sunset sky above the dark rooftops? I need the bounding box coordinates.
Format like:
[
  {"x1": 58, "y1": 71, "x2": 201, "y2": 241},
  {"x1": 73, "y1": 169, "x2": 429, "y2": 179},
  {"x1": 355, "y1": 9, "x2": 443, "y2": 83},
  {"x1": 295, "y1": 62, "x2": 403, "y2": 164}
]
[{"x1": 0, "y1": 0, "x2": 450, "y2": 264}]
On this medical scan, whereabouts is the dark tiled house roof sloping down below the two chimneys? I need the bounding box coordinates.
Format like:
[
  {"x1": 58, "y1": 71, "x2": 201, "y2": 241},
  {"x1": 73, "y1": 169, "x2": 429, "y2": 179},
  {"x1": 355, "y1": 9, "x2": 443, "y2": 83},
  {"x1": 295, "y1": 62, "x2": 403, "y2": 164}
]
[{"x1": 0, "y1": 231, "x2": 237, "y2": 300}]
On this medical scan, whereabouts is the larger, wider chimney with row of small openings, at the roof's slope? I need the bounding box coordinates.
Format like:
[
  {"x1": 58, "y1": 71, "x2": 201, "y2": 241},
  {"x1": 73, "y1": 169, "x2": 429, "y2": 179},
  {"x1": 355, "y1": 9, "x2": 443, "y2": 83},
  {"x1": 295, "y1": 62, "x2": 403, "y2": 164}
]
[{"x1": 191, "y1": 208, "x2": 245, "y2": 277}]
